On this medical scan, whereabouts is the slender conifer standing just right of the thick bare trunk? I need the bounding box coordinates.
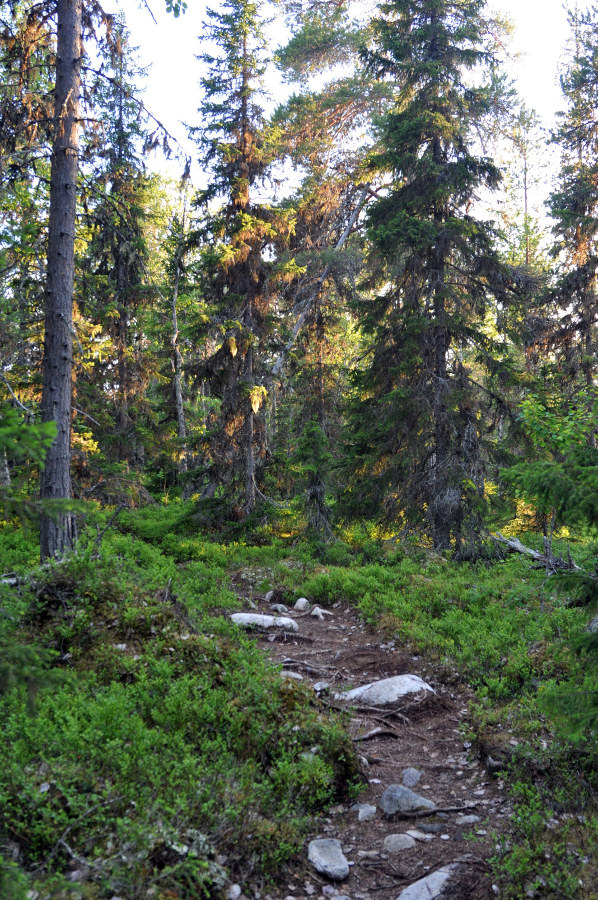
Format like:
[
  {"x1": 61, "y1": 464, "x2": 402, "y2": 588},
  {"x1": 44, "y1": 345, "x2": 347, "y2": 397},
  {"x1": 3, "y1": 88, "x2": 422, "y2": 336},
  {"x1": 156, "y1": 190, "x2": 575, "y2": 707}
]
[{"x1": 77, "y1": 16, "x2": 154, "y2": 468}]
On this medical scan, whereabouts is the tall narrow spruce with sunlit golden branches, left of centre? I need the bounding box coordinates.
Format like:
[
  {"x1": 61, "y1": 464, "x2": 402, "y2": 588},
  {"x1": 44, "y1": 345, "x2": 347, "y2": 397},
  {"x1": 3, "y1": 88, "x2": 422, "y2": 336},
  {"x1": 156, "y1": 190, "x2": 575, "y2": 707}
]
[{"x1": 193, "y1": 0, "x2": 291, "y2": 515}]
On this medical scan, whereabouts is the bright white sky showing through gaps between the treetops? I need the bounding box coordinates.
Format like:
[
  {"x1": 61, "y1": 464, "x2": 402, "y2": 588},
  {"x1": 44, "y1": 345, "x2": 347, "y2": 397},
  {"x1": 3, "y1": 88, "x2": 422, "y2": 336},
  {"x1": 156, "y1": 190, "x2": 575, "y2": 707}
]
[{"x1": 118, "y1": 0, "x2": 584, "y2": 183}]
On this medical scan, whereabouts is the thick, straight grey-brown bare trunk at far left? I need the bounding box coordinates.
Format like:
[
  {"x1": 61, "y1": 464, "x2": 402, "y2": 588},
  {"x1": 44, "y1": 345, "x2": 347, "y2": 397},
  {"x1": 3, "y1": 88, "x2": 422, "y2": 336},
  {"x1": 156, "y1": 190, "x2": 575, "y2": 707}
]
[{"x1": 40, "y1": 0, "x2": 83, "y2": 560}]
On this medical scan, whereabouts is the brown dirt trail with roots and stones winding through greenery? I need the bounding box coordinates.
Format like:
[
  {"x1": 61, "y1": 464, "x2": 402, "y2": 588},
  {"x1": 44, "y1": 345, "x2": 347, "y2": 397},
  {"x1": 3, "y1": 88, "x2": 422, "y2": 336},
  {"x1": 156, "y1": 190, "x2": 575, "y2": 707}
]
[{"x1": 241, "y1": 601, "x2": 511, "y2": 900}]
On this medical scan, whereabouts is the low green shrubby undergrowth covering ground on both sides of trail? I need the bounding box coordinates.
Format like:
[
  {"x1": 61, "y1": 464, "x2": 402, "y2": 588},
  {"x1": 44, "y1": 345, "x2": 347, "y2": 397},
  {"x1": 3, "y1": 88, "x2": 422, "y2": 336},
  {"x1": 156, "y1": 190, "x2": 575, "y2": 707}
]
[{"x1": 0, "y1": 503, "x2": 598, "y2": 900}]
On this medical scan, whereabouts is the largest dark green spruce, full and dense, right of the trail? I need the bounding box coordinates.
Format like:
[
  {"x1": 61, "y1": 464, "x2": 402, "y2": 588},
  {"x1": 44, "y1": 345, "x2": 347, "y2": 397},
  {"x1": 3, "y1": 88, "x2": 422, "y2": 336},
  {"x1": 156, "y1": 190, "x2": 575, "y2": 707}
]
[{"x1": 348, "y1": 0, "x2": 507, "y2": 554}]
